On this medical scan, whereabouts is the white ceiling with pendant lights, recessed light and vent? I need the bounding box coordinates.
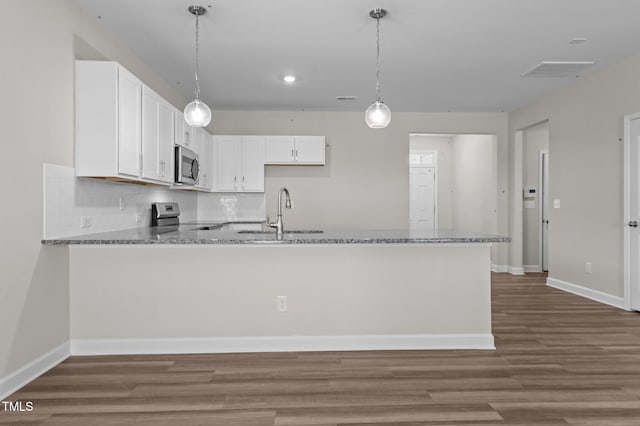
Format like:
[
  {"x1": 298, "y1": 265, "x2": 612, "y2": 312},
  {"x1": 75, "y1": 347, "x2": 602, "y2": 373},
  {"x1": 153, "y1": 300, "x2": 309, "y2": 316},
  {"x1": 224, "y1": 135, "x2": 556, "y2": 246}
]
[{"x1": 75, "y1": 0, "x2": 640, "y2": 112}]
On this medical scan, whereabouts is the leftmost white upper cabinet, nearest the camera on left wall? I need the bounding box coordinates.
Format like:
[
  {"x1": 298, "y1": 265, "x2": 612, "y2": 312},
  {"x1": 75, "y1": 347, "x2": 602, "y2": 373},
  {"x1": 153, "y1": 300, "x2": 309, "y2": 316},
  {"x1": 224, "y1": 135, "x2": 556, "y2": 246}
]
[{"x1": 76, "y1": 61, "x2": 142, "y2": 179}]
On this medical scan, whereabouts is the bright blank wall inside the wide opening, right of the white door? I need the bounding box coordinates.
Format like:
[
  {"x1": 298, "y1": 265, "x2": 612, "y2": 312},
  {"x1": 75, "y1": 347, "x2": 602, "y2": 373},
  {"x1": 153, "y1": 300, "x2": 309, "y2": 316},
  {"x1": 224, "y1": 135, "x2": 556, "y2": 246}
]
[{"x1": 453, "y1": 135, "x2": 497, "y2": 235}]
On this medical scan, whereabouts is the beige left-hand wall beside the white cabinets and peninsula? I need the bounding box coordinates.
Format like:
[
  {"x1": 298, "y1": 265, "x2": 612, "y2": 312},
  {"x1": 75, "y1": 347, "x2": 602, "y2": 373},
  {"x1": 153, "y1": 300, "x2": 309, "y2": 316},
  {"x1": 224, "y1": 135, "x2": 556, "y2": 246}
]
[{"x1": 0, "y1": 0, "x2": 184, "y2": 381}]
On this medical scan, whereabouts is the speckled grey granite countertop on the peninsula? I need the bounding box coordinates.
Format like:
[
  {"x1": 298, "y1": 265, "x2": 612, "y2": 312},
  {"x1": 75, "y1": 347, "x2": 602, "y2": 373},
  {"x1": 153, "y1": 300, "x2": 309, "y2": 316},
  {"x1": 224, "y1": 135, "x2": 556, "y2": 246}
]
[{"x1": 42, "y1": 222, "x2": 511, "y2": 245}]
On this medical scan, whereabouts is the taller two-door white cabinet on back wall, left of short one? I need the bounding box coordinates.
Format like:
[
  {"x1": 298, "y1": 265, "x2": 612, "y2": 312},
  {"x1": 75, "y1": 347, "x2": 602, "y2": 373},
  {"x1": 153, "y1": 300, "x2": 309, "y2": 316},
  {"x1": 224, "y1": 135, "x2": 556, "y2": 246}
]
[{"x1": 215, "y1": 135, "x2": 264, "y2": 192}]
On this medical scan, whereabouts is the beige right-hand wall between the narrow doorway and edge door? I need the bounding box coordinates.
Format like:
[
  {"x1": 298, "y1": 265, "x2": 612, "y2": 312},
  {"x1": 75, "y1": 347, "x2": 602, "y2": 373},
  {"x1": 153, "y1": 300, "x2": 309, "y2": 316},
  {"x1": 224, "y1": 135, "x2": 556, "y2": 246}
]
[{"x1": 509, "y1": 56, "x2": 640, "y2": 297}]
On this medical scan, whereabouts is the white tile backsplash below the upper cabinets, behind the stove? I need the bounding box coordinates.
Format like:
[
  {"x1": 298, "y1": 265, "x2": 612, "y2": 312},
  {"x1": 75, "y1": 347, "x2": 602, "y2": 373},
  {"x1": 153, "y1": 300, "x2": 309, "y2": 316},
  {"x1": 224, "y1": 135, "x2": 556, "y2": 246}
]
[{"x1": 43, "y1": 163, "x2": 265, "y2": 239}]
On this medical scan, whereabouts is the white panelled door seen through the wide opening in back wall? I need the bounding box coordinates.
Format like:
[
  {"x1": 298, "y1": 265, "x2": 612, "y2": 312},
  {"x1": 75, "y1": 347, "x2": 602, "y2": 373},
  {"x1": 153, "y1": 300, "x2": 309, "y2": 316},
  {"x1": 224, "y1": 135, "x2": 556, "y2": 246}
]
[{"x1": 409, "y1": 166, "x2": 436, "y2": 231}]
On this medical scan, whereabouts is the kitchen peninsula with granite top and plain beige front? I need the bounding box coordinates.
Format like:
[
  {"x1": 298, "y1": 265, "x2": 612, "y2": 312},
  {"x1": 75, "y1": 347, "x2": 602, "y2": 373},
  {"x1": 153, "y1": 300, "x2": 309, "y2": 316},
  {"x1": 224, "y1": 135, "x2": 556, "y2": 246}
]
[{"x1": 43, "y1": 228, "x2": 509, "y2": 355}]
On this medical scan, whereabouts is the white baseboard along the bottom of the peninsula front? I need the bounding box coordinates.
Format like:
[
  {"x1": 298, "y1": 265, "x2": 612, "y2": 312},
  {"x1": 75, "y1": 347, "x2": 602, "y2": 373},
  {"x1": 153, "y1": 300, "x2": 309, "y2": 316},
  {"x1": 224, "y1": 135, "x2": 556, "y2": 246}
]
[{"x1": 71, "y1": 334, "x2": 495, "y2": 355}]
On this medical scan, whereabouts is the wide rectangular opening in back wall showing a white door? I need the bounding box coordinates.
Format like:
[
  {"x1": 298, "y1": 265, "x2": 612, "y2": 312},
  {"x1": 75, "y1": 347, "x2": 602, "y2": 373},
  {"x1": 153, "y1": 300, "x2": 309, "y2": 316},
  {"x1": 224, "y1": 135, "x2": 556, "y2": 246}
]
[{"x1": 408, "y1": 133, "x2": 498, "y2": 243}]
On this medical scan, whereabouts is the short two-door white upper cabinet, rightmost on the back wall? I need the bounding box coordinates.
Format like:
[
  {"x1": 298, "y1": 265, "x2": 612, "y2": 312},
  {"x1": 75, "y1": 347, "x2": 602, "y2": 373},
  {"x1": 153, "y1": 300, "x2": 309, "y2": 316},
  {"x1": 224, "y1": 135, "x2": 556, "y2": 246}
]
[{"x1": 265, "y1": 136, "x2": 325, "y2": 165}]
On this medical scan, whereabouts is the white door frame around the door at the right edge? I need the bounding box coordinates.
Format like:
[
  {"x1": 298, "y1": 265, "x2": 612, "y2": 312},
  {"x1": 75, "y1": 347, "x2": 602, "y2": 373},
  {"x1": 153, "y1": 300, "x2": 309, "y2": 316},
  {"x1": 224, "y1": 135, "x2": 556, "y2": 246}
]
[{"x1": 622, "y1": 113, "x2": 640, "y2": 311}]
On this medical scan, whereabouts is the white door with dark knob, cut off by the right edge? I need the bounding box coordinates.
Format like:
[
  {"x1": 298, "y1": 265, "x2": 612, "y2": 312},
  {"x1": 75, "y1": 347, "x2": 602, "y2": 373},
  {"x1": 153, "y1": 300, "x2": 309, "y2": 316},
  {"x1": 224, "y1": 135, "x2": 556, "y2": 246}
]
[{"x1": 624, "y1": 114, "x2": 640, "y2": 311}]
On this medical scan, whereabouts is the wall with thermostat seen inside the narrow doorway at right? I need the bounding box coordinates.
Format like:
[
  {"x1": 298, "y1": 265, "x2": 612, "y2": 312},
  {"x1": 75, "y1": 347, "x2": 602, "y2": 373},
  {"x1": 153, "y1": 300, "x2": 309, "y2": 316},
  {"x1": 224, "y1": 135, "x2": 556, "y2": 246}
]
[{"x1": 521, "y1": 122, "x2": 549, "y2": 267}]
